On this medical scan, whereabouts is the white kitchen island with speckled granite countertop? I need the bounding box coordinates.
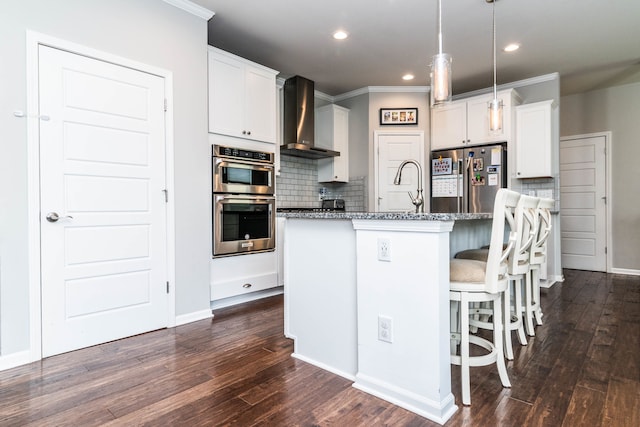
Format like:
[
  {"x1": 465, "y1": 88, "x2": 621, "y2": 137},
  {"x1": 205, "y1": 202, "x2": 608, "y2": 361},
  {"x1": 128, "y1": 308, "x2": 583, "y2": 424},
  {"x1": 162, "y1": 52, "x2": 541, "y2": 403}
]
[{"x1": 278, "y1": 212, "x2": 491, "y2": 424}]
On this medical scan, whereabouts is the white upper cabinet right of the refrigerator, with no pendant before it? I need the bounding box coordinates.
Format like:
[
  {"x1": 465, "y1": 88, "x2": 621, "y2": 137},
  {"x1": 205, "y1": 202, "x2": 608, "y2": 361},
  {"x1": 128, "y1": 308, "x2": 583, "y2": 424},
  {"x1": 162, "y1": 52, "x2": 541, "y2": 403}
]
[{"x1": 515, "y1": 100, "x2": 555, "y2": 178}]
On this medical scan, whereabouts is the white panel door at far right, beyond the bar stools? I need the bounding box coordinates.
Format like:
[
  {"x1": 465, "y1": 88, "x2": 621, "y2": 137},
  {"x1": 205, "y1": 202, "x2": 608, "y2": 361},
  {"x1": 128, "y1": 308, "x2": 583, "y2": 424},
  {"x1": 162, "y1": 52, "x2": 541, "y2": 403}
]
[{"x1": 560, "y1": 136, "x2": 607, "y2": 271}]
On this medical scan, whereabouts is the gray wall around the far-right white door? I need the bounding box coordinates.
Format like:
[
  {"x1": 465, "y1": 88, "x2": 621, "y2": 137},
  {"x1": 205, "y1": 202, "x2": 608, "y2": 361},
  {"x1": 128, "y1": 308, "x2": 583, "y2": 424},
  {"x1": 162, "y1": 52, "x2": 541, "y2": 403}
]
[{"x1": 560, "y1": 83, "x2": 640, "y2": 270}]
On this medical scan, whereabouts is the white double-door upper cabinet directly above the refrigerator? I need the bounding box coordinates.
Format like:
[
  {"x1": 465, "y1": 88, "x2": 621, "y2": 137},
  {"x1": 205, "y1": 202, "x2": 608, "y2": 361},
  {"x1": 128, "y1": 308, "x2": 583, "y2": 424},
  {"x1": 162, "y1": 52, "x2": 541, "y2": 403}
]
[{"x1": 431, "y1": 89, "x2": 520, "y2": 150}]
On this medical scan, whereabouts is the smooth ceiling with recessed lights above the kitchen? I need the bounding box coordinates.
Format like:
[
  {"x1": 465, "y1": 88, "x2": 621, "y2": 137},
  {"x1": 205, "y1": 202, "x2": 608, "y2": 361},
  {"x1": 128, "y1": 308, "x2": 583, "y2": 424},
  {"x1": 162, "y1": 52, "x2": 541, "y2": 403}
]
[{"x1": 192, "y1": 0, "x2": 640, "y2": 96}]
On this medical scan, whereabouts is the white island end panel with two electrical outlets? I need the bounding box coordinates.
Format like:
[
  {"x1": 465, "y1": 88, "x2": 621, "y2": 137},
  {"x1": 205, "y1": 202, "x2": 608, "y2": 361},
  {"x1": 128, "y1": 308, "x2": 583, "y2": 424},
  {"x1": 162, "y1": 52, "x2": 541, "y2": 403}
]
[{"x1": 354, "y1": 220, "x2": 457, "y2": 423}]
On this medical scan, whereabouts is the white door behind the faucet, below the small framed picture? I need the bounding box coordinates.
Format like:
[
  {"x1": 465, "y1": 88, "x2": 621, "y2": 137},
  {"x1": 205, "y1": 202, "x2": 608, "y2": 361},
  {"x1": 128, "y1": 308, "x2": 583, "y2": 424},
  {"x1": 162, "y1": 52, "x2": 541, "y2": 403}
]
[{"x1": 374, "y1": 131, "x2": 429, "y2": 212}]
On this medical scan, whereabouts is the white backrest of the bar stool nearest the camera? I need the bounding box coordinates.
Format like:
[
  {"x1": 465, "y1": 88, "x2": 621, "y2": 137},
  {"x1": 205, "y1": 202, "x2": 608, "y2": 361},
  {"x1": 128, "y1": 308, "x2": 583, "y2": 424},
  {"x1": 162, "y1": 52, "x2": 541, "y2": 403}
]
[{"x1": 485, "y1": 188, "x2": 521, "y2": 293}]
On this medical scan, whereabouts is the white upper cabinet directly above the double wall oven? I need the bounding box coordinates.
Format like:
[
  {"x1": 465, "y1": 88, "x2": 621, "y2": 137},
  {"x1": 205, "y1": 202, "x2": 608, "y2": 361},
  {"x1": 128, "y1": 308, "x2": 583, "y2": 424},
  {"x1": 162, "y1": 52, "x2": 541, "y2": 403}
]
[{"x1": 208, "y1": 47, "x2": 278, "y2": 143}]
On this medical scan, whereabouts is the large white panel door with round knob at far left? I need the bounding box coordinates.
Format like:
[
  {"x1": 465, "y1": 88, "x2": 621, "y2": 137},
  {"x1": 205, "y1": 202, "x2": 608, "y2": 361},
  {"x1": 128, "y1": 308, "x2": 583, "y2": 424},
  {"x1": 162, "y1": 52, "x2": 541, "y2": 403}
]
[{"x1": 39, "y1": 46, "x2": 168, "y2": 357}]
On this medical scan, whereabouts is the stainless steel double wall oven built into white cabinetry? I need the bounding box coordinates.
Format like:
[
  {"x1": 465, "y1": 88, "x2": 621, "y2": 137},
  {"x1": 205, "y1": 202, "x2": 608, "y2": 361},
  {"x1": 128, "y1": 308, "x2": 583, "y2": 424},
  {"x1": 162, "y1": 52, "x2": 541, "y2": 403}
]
[{"x1": 212, "y1": 145, "x2": 276, "y2": 257}]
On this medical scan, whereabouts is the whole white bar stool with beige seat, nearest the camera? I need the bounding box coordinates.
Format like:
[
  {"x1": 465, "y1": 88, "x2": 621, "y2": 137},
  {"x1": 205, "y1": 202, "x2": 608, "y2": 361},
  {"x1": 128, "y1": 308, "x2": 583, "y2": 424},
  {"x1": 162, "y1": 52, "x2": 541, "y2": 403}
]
[{"x1": 449, "y1": 189, "x2": 520, "y2": 405}]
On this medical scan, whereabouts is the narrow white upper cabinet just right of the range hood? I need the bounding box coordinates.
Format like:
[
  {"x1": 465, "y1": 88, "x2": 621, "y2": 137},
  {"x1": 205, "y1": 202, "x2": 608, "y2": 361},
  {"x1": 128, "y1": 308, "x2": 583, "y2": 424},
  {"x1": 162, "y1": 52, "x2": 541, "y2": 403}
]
[{"x1": 315, "y1": 104, "x2": 349, "y2": 182}]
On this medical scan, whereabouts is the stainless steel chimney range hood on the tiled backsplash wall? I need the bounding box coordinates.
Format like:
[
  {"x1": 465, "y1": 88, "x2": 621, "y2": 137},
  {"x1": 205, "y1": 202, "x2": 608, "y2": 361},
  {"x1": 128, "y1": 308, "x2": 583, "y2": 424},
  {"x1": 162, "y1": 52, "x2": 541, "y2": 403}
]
[{"x1": 280, "y1": 76, "x2": 340, "y2": 159}]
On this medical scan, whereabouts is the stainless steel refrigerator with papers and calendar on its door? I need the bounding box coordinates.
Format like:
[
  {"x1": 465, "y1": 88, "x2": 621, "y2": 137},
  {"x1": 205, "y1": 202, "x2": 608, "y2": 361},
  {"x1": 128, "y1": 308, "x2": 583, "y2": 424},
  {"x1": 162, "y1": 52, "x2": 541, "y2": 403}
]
[{"x1": 431, "y1": 144, "x2": 507, "y2": 213}]
